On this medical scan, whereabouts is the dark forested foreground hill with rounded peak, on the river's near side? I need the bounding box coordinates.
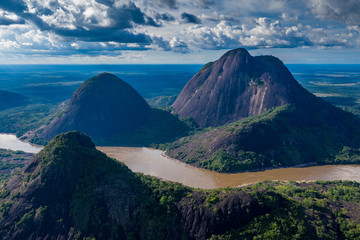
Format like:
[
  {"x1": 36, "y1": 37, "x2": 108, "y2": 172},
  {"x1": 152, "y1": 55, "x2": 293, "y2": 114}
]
[{"x1": 0, "y1": 132, "x2": 360, "y2": 240}]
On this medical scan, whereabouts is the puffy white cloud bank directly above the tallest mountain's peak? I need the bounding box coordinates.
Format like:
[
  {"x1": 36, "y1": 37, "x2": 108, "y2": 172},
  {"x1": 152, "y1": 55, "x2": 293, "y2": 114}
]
[{"x1": 185, "y1": 18, "x2": 311, "y2": 49}]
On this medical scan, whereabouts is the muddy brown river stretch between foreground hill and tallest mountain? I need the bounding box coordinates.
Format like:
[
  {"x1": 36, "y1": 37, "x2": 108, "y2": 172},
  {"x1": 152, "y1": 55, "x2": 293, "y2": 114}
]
[{"x1": 98, "y1": 147, "x2": 360, "y2": 188}]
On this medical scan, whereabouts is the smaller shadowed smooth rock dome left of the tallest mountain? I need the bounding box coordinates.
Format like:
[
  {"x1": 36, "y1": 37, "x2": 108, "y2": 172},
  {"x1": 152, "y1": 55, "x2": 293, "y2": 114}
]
[{"x1": 39, "y1": 73, "x2": 150, "y2": 141}]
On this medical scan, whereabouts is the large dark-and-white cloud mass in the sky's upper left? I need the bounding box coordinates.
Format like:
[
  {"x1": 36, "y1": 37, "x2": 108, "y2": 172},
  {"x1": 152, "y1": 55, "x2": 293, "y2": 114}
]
[{"x1": 0, "y1": 0, "x2": 160, "y2": 48}]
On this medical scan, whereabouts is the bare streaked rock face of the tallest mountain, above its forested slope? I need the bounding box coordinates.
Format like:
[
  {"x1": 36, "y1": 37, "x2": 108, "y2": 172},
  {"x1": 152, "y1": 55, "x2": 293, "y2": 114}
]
[{"x1": 173, "y1": 48, "x2": 312, "y2": 127}]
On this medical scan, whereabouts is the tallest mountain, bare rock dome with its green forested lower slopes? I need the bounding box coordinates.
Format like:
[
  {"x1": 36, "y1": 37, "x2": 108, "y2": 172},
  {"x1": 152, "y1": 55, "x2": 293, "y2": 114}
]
[{"x1": 165, "y1": 49, "x2": 360, "y2": 172}]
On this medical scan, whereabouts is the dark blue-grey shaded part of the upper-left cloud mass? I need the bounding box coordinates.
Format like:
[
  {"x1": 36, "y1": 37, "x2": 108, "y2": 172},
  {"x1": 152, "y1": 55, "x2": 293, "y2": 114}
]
[{"x1": 0, "y1": 0, "x2": 160, "y2": 45}]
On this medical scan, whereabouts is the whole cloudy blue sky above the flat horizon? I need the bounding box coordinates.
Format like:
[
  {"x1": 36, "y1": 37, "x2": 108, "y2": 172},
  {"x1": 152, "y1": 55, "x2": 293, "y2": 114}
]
[{"x1": 0, "y1": 0, "x2": 360, "y2": 64}]
